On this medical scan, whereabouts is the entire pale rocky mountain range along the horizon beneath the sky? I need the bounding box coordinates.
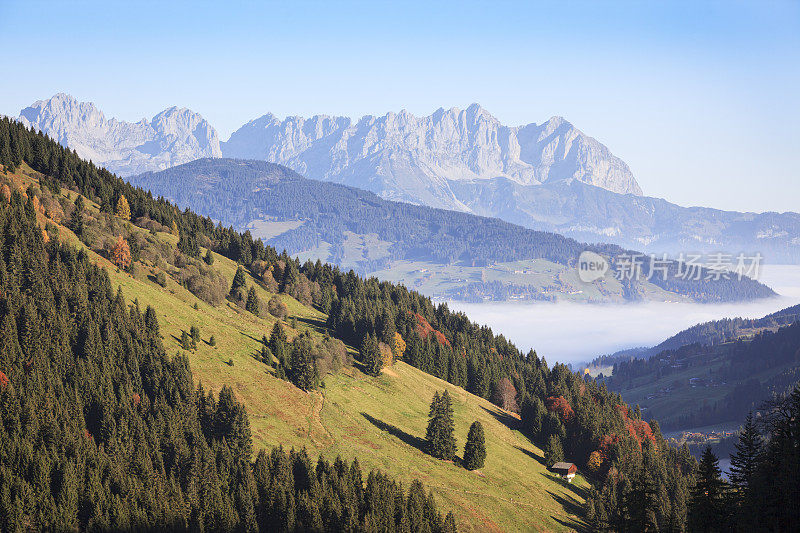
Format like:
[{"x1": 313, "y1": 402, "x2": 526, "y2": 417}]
[{"x1": 15, "y1": 94, "x2": 800, "y2": 263}]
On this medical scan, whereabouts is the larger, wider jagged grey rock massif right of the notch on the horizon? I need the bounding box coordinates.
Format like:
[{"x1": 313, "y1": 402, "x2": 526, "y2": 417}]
[{"x1": 222, "y1": 104, "x2": 642, "y2": 211}]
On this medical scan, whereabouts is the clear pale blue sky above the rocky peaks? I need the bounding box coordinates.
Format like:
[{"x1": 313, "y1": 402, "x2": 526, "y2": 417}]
[{"x1": 0, "y1": 0, "x2": 800, "y2": 211}]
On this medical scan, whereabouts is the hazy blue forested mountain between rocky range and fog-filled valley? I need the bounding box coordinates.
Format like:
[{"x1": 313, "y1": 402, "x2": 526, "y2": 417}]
[{"x1": 132, "y1": 159, "x2": 774, "y2": 302}]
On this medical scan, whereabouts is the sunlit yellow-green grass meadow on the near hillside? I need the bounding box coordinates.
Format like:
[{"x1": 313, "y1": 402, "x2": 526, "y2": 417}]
[{"x1": 12, "y1": 164, "x2": 589, "y2": 531}]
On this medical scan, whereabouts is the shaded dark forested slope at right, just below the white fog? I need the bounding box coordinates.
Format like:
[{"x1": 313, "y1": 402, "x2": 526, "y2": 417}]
[{"x1": 606, "y1": 306, "x2": 800, "y2": 430}]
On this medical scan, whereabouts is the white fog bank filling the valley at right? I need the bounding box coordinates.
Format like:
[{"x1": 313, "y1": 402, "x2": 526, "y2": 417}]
[{"x1": 448, "y1": 265, "x2": 800, "y2": 364}]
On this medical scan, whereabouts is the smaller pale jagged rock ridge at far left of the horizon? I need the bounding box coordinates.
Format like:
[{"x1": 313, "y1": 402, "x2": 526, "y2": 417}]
[{"x1": 19, "y1": 93, "x2": 222, "y2": 176}]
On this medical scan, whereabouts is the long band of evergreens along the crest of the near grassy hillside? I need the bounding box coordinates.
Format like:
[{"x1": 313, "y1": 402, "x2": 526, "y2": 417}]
[{"x1": 0, "y1": 115, "x2": 694, "y2": 527}]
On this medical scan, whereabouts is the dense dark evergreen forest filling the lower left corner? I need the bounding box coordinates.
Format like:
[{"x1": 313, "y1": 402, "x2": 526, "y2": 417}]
[{"x1": 0, "y1": 158, "x2": 455, "y2": 532}]
